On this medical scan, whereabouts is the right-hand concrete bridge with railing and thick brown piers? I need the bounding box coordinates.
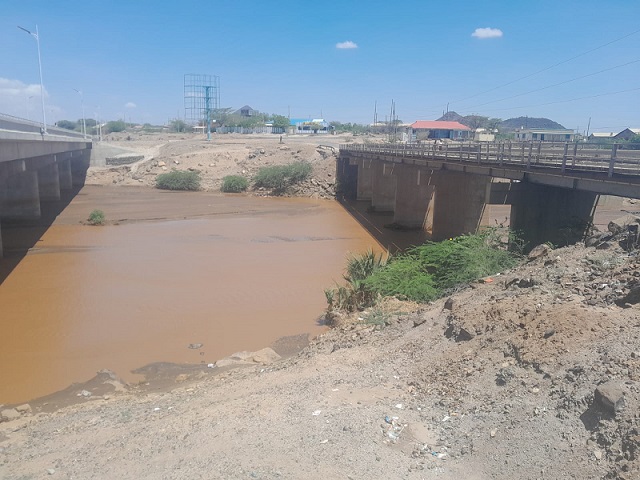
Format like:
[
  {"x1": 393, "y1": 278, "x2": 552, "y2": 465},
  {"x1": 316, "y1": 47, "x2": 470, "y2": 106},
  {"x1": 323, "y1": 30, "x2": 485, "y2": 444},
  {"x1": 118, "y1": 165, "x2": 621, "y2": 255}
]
[{"x1": 337, "y1": 142, "x2": 640, "y2": 246}]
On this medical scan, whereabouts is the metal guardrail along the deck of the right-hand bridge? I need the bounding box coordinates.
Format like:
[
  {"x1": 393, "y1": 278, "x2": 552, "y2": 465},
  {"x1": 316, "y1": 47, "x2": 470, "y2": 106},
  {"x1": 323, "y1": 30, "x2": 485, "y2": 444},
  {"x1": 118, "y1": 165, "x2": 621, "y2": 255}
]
[{"x1": 340, "y1": 142, "x2": 640, "y2": 177}]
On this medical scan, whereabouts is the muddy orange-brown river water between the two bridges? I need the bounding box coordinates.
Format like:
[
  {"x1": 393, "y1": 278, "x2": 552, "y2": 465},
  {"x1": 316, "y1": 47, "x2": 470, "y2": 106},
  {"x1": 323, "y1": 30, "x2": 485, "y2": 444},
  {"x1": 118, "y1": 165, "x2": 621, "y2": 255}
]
[{"x1": 0, "y1": 186, "x2": 379, "y2": 403}]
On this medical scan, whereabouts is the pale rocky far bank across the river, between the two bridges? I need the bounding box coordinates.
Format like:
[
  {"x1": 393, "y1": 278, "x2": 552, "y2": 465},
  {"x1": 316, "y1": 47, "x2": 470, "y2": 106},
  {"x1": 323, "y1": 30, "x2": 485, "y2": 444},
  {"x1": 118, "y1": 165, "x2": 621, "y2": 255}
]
[{"x1": 87, "y1": 133, "x2": 344, "y2": 198}]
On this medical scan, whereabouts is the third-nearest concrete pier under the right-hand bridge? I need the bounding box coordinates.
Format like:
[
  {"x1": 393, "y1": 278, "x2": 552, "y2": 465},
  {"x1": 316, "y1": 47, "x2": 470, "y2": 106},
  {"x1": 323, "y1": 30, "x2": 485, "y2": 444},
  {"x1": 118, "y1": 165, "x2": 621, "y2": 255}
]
[{"x1": 393, "y1": 165, "x2": 435, "y2": 228}]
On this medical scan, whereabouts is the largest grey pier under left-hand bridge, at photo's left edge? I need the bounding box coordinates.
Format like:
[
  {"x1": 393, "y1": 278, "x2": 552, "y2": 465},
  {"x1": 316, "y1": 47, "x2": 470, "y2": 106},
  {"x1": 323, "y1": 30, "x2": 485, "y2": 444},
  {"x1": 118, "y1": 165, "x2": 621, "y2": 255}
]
[{"x1": 0, "y1": 171, "x2": 40, "y2": 220}]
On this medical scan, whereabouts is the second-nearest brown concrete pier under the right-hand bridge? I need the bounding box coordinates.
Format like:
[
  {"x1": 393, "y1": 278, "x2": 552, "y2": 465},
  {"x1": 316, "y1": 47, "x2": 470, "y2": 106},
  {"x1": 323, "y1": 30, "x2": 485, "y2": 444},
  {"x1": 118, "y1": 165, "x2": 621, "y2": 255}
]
[{"x1": 432, "y1": 172, "x2": 491, "y2": 241}]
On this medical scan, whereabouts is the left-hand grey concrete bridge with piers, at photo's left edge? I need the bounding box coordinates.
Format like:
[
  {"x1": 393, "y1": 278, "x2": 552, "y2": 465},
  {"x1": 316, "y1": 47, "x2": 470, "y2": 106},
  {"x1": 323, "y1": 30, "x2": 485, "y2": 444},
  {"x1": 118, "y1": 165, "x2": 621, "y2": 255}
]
[{"x1": 0, "y1": 115, "x2": 92, "y2": 258}]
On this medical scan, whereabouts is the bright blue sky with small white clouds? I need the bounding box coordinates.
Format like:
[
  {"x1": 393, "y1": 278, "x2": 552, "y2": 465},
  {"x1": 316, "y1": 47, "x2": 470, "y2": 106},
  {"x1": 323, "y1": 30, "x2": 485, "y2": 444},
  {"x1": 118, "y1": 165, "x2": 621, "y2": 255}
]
[{"x1": 0, "y1": 0, "x2": 640, "y2": 131}]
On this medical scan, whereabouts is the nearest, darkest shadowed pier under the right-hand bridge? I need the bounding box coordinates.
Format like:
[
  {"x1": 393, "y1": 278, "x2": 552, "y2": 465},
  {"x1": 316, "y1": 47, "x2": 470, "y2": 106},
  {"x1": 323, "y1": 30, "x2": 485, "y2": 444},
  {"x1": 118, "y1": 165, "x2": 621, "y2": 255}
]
[{"x1": 510, "y1": 182, "x2": 597, "y2": 248}]
